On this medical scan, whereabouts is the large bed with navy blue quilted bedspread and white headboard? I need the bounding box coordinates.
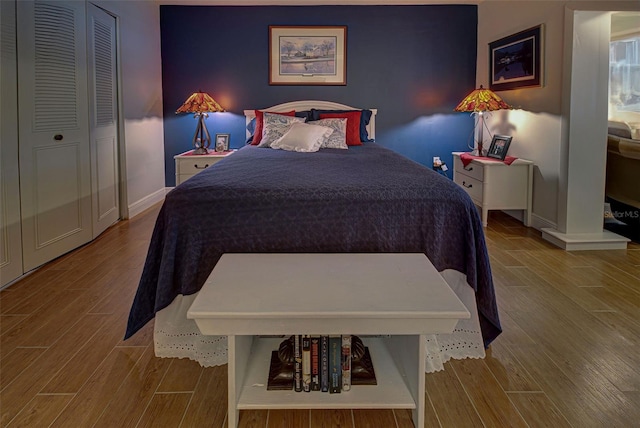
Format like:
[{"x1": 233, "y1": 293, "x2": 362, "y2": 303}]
[{"x1": 125, "y1": 101, "x2": 502, "y2": 372}]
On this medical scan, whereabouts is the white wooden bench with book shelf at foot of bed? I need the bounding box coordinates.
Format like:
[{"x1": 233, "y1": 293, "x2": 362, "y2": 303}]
[{"x1": 187, "y1": 253, "x2": 470, "y2": 427}]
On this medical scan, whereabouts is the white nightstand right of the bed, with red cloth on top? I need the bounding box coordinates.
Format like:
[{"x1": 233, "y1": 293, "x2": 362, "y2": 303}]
[{"x1": 452, "y1": 152, "x2": 533, "y2": 227}]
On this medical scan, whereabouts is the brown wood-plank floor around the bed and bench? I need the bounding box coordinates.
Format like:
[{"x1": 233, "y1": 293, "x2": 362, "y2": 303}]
[{"x1": 0, "y1": 207, "x2": 640, "y2": 428}]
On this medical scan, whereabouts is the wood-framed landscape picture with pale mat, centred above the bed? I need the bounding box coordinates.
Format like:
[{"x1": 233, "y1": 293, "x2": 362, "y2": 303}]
[{"x1": 269, "y1": 25, "x2": 347, "y2": 85}]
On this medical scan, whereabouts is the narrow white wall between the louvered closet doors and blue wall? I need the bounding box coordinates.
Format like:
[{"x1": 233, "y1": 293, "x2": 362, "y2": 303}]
[{"x1": 92, "y1": 0, "x2": 165, "y2": 217}]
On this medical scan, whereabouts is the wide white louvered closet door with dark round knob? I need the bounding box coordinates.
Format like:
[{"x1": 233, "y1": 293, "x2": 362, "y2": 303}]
[{"x1": 17, "y1": 0, "x2": 92, "y2": 272}]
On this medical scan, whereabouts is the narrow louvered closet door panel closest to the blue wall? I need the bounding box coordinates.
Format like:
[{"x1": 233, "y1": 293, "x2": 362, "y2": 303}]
[{"x1": 87, "y1": 4, "x2": 120, "y2": 238}]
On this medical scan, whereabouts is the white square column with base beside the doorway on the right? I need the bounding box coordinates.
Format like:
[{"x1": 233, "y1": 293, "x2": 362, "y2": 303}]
[{"x1": 542, "y1": 9, "x2": 628, "y2": 250}]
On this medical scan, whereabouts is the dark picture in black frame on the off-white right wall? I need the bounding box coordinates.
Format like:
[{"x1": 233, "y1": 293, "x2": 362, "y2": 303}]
[{"x1": 489, "y1": 24, "x2": 544, "y2": 91}]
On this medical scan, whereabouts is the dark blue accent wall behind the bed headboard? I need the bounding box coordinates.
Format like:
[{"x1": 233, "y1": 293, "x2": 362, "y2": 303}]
[{"x1": 160, "y1": 5, "x2": 478, "y2": 186}]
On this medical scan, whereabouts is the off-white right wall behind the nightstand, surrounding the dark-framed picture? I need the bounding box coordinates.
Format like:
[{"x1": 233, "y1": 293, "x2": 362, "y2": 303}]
[{"x1": 477, "y1": 0, "x2": 640, "y2": 231}]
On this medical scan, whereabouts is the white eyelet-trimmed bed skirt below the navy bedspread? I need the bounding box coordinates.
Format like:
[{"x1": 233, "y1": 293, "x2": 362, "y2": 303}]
[{"x1": 153, "y1": 270, "x2": 485, "y2": 373}]
